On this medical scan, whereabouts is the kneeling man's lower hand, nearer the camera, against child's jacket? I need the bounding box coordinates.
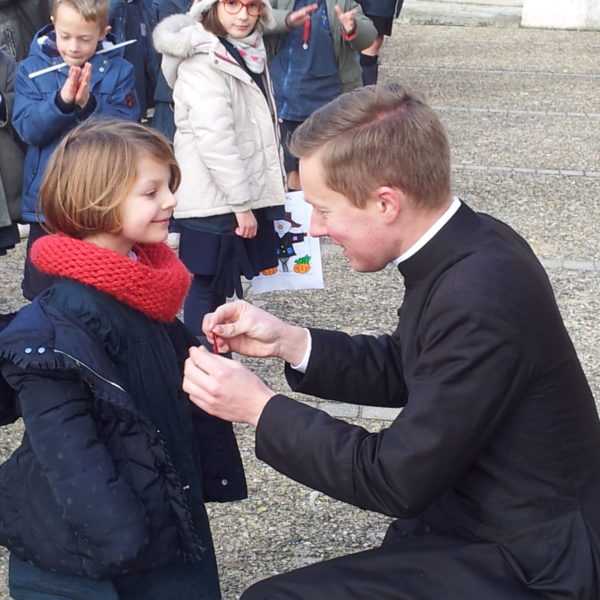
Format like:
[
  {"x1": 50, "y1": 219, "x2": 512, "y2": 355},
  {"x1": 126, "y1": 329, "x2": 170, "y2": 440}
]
[{"x1": 183, "y1": 346, "x2": 275, "y2": 427}]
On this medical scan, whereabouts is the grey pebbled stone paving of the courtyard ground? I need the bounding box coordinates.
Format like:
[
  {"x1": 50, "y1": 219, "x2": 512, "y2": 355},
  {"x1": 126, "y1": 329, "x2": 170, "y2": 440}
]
[{"x1": 0, "y1": 5, "x2": 600, "y2": 600}]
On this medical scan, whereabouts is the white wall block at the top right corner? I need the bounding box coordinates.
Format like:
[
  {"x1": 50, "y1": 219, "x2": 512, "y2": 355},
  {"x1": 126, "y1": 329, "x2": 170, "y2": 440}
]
[{"x1": 521, "y1": 0, "x2": 600, "y2": 29}]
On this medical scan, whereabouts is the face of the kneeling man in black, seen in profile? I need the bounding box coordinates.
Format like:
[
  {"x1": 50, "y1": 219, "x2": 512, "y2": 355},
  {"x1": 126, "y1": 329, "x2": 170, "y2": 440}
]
[{"x1": 299, "y1": 151, "x2": 397, "y2": 273}]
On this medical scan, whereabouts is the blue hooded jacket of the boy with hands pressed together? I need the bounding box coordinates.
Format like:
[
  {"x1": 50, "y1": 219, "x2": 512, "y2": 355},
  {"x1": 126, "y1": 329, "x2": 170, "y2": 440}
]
[{"x1": 13, "y1": 25, "x2": 140, "y2": 222}]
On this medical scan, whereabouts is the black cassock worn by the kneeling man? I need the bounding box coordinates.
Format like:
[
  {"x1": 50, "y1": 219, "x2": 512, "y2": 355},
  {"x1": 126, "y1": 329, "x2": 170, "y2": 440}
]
[{"x1": 250, "y1": 204, "x2": 600, "y2": 600}]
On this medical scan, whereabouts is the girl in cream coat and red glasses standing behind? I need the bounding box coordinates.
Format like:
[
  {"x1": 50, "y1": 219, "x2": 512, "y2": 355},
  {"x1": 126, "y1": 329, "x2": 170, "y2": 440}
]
[{"x1": 154, "y1": 0, "x2": 285, "y2": 334}]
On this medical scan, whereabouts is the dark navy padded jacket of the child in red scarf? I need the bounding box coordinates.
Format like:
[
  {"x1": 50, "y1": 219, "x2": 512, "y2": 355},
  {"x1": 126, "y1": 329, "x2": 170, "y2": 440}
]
[{"x1": 0, "y1": 279, "x2": 246, "y2": 578}]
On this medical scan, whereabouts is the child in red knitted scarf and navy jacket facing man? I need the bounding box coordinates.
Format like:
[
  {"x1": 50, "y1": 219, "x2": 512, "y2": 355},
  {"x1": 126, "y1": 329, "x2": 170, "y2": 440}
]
[{"x1": 0, "y1": 119, "x2": 246, "y2": 600}]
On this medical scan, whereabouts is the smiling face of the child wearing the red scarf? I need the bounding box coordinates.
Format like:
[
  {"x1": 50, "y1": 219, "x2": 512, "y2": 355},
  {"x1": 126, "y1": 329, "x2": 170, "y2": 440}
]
[{"x1": 86, "y1": 153, "x2": 177, "y2": 256}]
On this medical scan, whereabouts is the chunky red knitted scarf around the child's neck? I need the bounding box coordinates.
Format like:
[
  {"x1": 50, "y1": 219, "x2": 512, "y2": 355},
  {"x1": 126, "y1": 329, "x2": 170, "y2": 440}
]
[{"x1": 31, "y1": 234, "x2": 191, "y2": 322}]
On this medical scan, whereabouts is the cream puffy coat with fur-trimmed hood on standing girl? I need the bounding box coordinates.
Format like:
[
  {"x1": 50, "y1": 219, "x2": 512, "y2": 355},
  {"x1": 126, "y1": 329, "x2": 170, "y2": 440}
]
[{"x1": 153, "y1": 6, "x2": 285, "y2": 219}]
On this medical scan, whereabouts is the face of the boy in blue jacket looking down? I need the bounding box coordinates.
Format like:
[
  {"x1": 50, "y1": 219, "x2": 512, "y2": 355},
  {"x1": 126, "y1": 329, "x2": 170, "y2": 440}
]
[{"x1": 52, "y1": 3, "x2": 110, "y2": 67}]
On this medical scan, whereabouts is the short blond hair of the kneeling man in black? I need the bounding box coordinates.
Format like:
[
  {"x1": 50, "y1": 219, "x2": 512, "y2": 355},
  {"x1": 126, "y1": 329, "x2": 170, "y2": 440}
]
[{"x1": 291, "y1": 83, "x2": 451, "y2": 208}]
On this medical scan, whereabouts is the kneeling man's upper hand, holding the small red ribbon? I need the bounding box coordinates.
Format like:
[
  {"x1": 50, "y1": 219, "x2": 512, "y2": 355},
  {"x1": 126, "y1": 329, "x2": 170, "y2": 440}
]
[{"x1": 202, "y1": 300, "x2": 308, "y2": 364}]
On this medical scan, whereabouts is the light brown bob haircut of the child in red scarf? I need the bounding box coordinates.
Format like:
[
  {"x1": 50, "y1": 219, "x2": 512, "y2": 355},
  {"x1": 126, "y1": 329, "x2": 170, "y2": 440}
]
[{"x1": 39, "y1": 117, "x2": 181, "y2": 239}]
